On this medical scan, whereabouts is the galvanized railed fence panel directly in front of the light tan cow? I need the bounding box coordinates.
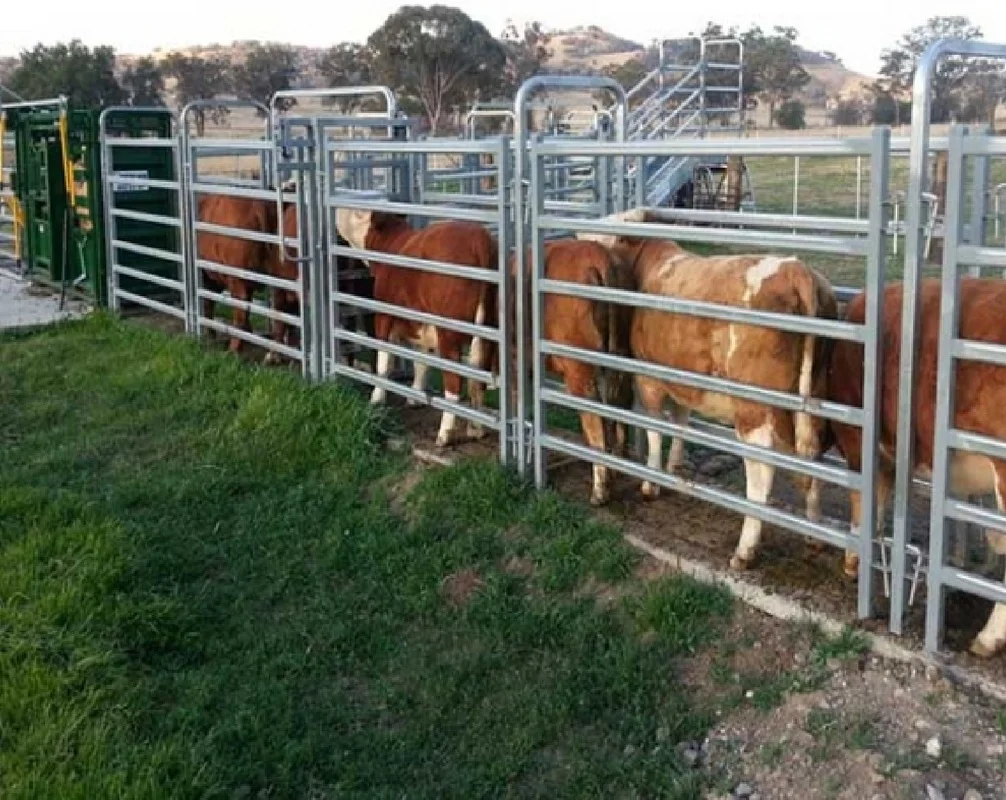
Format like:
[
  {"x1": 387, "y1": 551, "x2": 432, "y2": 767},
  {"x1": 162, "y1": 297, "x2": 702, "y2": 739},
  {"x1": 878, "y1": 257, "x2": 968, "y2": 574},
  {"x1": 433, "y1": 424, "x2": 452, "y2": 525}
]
[{"x1": 530, "y1": 129, "x2": 889, "y2": 617}]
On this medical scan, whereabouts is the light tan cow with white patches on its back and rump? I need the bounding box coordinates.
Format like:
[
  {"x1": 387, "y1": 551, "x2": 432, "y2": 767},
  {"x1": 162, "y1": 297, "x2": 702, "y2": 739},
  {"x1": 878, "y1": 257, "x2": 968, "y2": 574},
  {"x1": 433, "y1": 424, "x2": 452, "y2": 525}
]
[{"x1": 580, "y1": 209, "x2": 837, "y2": 570}]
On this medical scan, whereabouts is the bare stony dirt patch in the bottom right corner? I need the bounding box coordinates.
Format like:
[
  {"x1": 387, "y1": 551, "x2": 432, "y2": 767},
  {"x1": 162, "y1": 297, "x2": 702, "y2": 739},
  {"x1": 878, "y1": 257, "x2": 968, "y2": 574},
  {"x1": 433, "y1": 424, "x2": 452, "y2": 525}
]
[{"x1": 685, "y1": 608, "x2": 1006, "y2": 800}]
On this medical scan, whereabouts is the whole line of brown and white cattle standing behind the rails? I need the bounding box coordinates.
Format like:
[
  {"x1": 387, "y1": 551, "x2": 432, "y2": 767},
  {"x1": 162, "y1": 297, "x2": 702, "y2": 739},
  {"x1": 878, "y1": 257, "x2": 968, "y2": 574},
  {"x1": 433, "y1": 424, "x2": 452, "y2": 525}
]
[{"x1": 199, "y1": 196, "x2": 1006, "y2": 656}]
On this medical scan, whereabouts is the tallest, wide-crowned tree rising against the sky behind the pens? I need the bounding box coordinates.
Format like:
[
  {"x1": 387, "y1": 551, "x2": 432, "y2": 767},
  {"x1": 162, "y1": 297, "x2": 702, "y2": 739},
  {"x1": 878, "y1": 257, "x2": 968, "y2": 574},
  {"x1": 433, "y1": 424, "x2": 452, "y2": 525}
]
[{"x1": 367, "y1": 5, "x2": 507, "y2": 134}]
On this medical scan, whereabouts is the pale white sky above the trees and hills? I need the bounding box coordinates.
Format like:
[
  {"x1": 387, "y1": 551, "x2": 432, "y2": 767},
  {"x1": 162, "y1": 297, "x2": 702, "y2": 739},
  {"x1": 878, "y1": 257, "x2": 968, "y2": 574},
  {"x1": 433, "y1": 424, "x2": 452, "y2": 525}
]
[{"x1": 0, "y1": 0, "x2": 1006, "y2": 74}]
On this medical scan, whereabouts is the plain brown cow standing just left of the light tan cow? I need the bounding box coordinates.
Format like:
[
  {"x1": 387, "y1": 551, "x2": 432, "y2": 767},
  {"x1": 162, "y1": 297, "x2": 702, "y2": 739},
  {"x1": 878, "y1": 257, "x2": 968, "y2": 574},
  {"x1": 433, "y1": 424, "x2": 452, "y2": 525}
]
[{"x1": 526, "y1": 239, "x2": 634, "y2": 505}]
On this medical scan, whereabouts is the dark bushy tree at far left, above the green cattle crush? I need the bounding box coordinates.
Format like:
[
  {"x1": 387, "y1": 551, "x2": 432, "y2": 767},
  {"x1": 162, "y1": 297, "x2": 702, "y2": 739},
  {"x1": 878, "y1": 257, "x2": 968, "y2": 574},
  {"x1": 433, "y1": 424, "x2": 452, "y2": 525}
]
[{"x1": 9, "y1": 39, "x2": 127, "y2": 107}]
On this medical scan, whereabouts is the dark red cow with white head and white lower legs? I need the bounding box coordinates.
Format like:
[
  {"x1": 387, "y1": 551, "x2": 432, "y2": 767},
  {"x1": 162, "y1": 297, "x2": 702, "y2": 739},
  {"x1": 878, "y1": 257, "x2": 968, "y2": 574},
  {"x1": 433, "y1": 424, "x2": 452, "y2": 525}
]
[{"x1": 336, "y1": 208, "x2": 498, "y2": 447}]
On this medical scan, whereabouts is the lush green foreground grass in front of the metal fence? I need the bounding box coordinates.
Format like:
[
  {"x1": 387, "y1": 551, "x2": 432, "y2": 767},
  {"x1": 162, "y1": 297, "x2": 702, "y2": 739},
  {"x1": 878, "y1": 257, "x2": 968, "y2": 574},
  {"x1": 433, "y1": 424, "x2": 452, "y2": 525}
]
[{"x1": 0, "y1": 316, "x2": 730, "y2": 798}]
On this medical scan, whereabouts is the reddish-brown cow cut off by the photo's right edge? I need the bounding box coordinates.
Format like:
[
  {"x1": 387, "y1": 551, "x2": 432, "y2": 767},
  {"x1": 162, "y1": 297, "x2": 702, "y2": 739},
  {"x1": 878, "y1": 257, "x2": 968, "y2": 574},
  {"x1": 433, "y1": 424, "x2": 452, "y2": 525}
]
[{"x1": 828, "y1": 278, "x2": 1006, "y2": 656}]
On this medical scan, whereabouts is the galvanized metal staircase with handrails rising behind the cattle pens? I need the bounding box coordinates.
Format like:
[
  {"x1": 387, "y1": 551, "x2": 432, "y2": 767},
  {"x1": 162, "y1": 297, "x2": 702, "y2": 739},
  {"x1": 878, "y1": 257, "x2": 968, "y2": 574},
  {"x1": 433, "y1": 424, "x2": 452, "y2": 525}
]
[{"x1": 628, "y1": 37, "x2": 744, "y2": 206}]
